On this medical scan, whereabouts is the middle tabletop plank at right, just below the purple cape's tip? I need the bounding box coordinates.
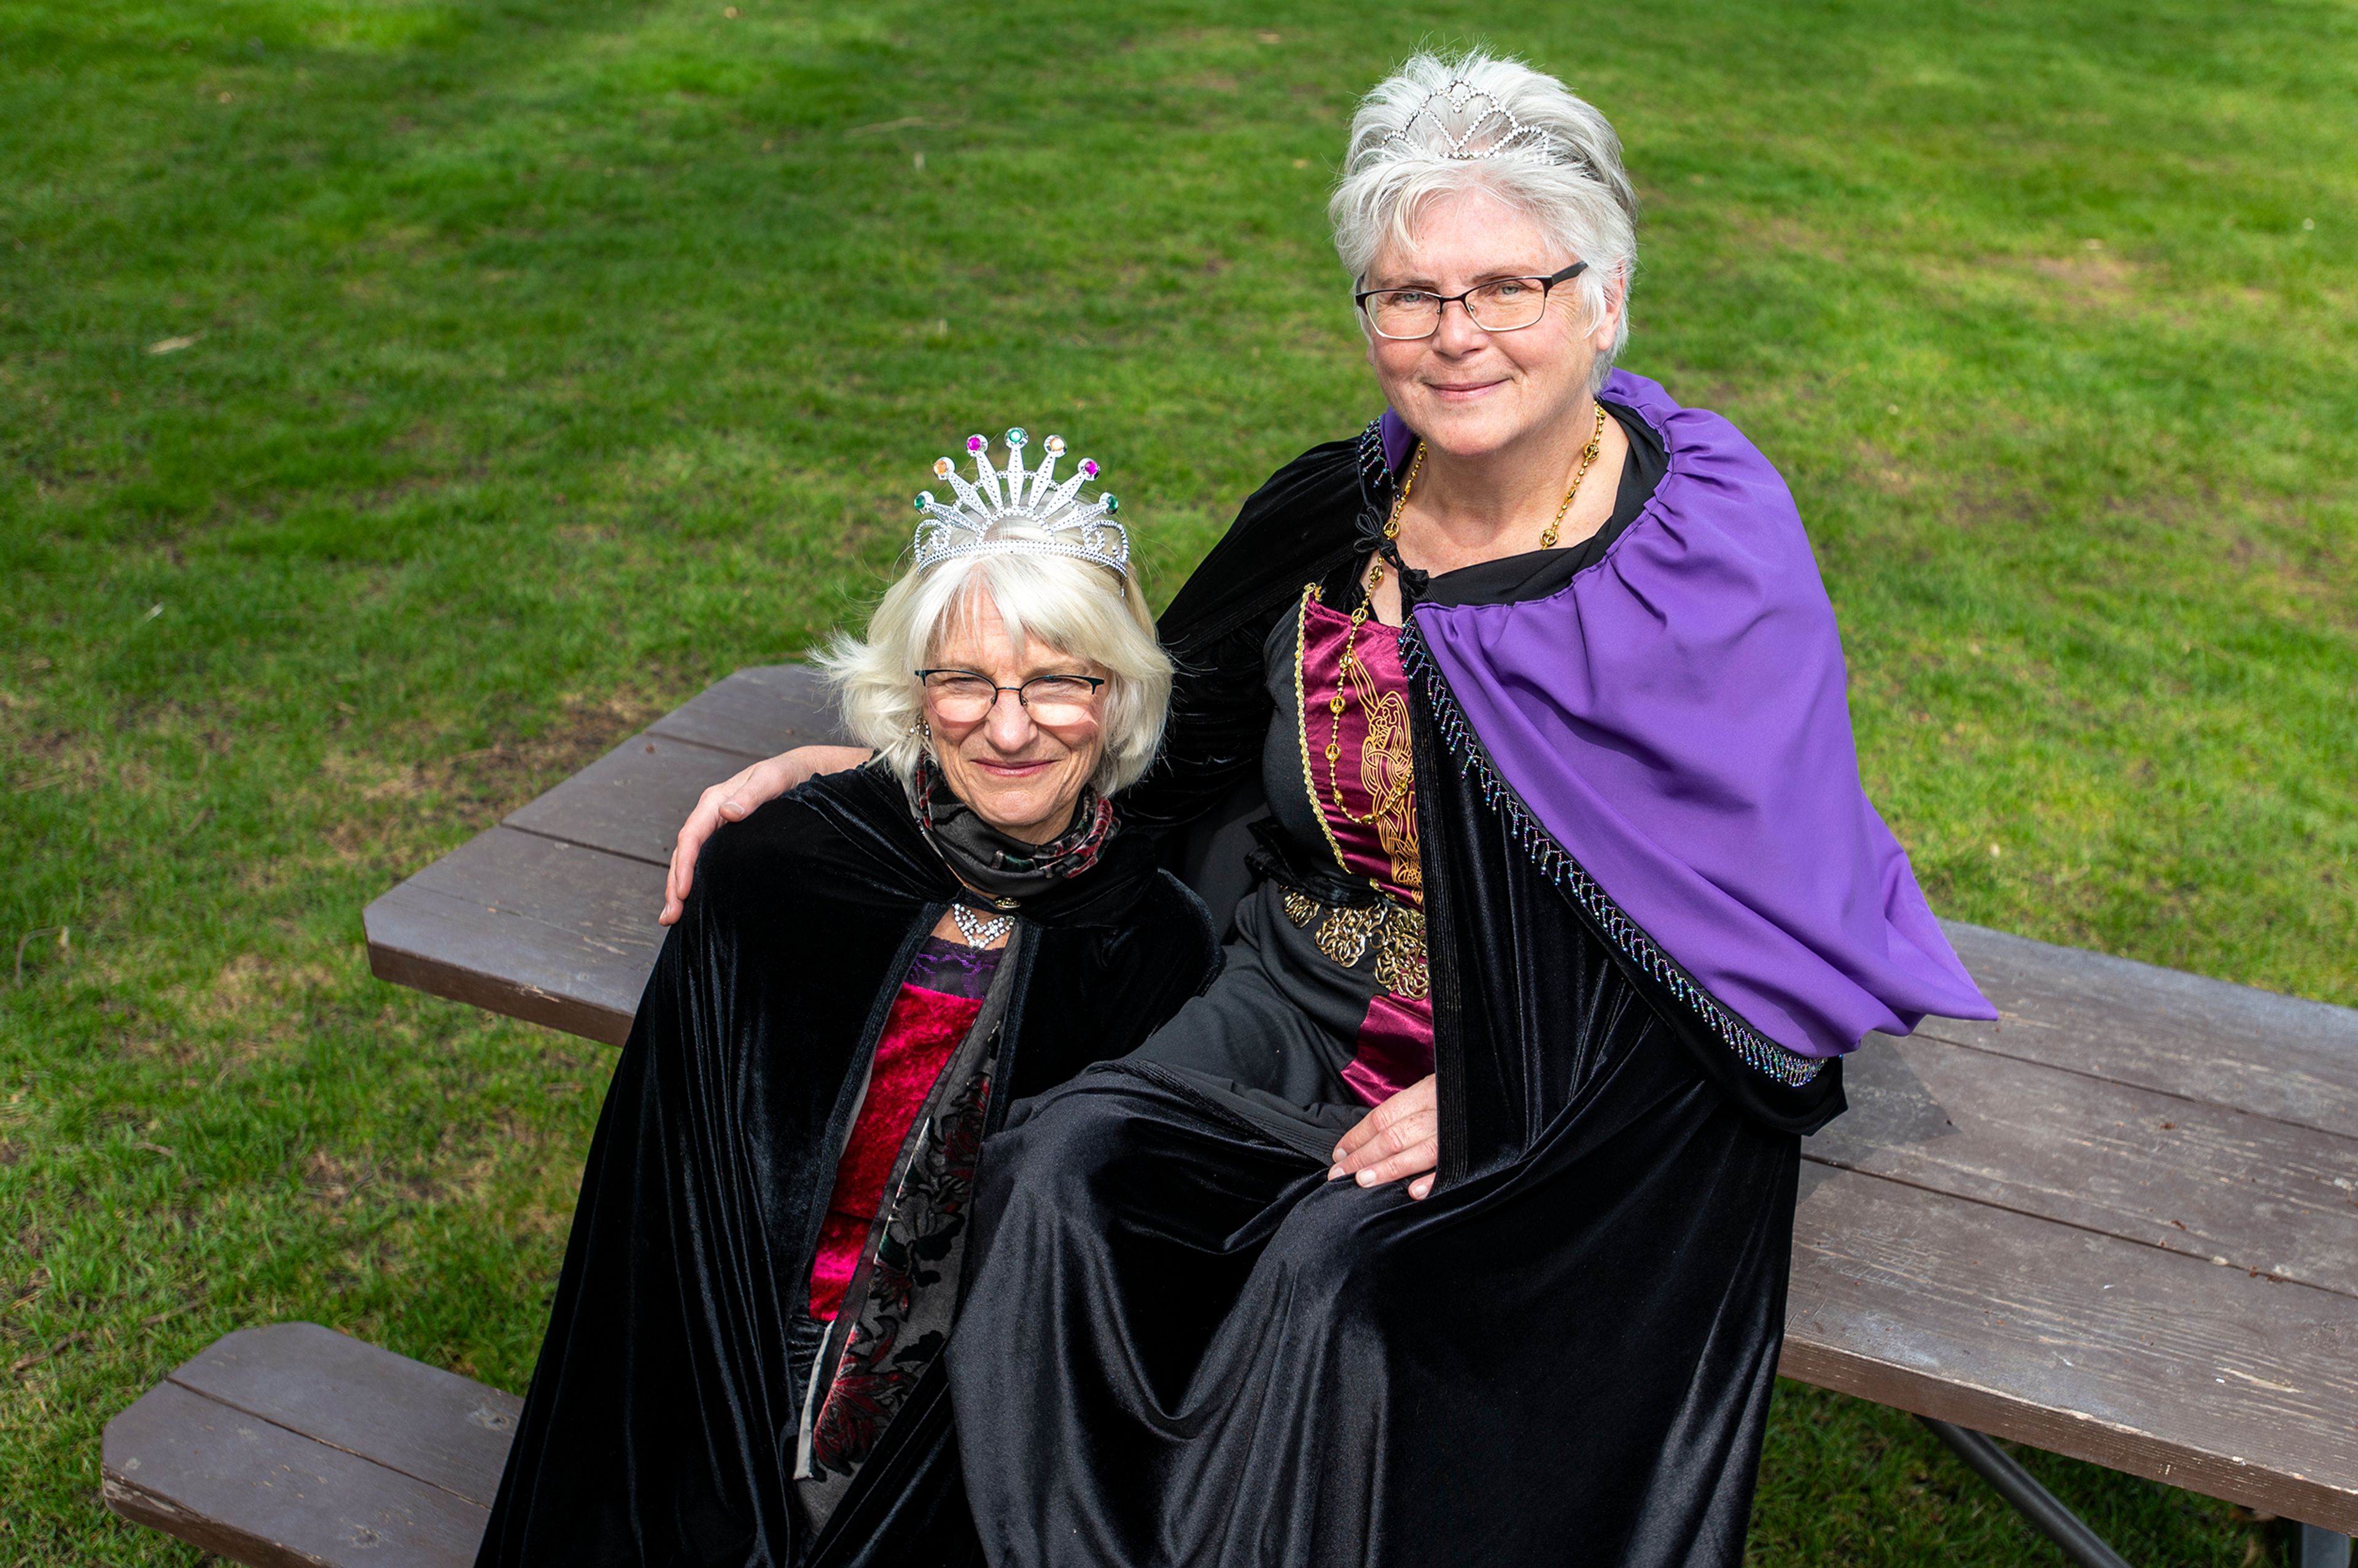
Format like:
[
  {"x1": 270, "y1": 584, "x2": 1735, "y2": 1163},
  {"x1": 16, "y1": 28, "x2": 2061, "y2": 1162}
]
[{"x1": 1802, "y1": 1035, "x2": 2358, "y2": 1297}]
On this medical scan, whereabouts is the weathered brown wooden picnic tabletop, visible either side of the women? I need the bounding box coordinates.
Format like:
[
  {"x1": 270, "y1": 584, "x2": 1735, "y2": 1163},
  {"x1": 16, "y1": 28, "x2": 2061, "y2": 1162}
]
[{"x1": 365, "y1": 665, "x2": 2358, "y2": 1532}]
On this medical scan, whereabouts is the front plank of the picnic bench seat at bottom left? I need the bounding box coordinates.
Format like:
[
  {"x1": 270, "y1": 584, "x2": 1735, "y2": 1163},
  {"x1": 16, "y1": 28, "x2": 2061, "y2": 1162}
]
[{"x1": 101, "y1": 1382, "x2": 491, "y2": 1568}]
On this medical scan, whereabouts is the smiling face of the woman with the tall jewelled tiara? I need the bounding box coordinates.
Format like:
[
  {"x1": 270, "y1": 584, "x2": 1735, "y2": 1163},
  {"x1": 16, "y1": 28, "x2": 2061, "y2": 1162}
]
[{"x1": 924, "y1": 589, "x2": 1106, "y2": 844}]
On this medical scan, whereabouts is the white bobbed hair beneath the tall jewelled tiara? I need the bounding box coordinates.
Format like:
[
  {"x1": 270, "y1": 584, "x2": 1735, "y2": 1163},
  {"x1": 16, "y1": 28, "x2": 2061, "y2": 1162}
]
[{"x1": 818, "y1": 547, "x2": 1172, "y2": 794}]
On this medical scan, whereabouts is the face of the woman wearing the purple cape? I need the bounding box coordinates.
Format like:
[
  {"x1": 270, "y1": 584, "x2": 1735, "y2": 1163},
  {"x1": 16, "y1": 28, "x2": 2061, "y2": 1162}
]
[{"x1": 1361, "y1": 191, "x2": 1620, "y2": 457}]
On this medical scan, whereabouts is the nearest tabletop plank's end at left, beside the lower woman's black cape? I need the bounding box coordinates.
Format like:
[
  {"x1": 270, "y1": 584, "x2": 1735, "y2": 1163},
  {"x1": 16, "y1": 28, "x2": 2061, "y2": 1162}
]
[{"x1": 361, "y1": 828, "x2": 663, "y2": 1044}]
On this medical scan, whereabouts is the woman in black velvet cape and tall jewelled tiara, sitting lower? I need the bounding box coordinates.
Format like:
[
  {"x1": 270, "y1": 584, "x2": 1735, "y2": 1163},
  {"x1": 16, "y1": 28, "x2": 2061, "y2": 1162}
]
[{"x1": 479, "y1": 429, "x2": 1216, "y2": 1568}]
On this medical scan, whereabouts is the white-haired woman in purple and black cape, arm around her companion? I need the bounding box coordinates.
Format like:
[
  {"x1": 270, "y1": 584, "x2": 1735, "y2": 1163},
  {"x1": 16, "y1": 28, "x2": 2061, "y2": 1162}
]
[{"x1": 674, "y1": 54, "x2": 1993, "y2": 1568}]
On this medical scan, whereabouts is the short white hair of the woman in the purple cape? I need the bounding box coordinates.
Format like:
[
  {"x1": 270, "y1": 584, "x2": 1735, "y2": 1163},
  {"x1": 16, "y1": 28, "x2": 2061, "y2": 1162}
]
[{"x1": 1328, "y1": 50, "x2": 1636, "y2": 392}]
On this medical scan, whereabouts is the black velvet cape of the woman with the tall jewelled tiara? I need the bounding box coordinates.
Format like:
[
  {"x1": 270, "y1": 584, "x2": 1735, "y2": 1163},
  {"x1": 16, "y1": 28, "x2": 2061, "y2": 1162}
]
[{"x1": 477, "y1": 766, "x2": 1219, "y2": 1568}]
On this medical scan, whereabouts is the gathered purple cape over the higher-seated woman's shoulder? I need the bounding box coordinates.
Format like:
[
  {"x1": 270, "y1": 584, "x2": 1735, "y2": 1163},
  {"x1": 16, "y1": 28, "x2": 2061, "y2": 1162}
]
[{"x1": 1384, "y1": 370, "x2": 1997, "y2": 1066}]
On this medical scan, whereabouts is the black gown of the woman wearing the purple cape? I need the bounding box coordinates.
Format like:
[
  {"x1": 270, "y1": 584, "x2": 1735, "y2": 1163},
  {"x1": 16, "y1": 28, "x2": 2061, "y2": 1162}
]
[{"x1": 948, "y1": 420, "x2": 1842, "y2": 1568}]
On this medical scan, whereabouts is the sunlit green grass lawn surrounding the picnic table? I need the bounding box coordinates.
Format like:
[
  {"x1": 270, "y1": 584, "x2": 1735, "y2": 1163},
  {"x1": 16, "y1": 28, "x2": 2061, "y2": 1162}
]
[{"x1": 0, "y1": 0, "x2": 2358, "y2": 1568}]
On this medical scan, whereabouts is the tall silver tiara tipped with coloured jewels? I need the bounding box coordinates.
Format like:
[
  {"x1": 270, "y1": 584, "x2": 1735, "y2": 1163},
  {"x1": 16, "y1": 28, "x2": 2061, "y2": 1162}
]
[{"x1": 912, "y1": 424, "x2": 1129, "y2": 578}]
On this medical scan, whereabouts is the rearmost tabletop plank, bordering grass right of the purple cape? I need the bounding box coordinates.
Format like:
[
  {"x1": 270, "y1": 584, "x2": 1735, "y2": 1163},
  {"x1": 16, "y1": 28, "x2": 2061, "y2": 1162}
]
[{"x1": 1917, "y1": 920, "x2": 2358, "y2": 1136}]
